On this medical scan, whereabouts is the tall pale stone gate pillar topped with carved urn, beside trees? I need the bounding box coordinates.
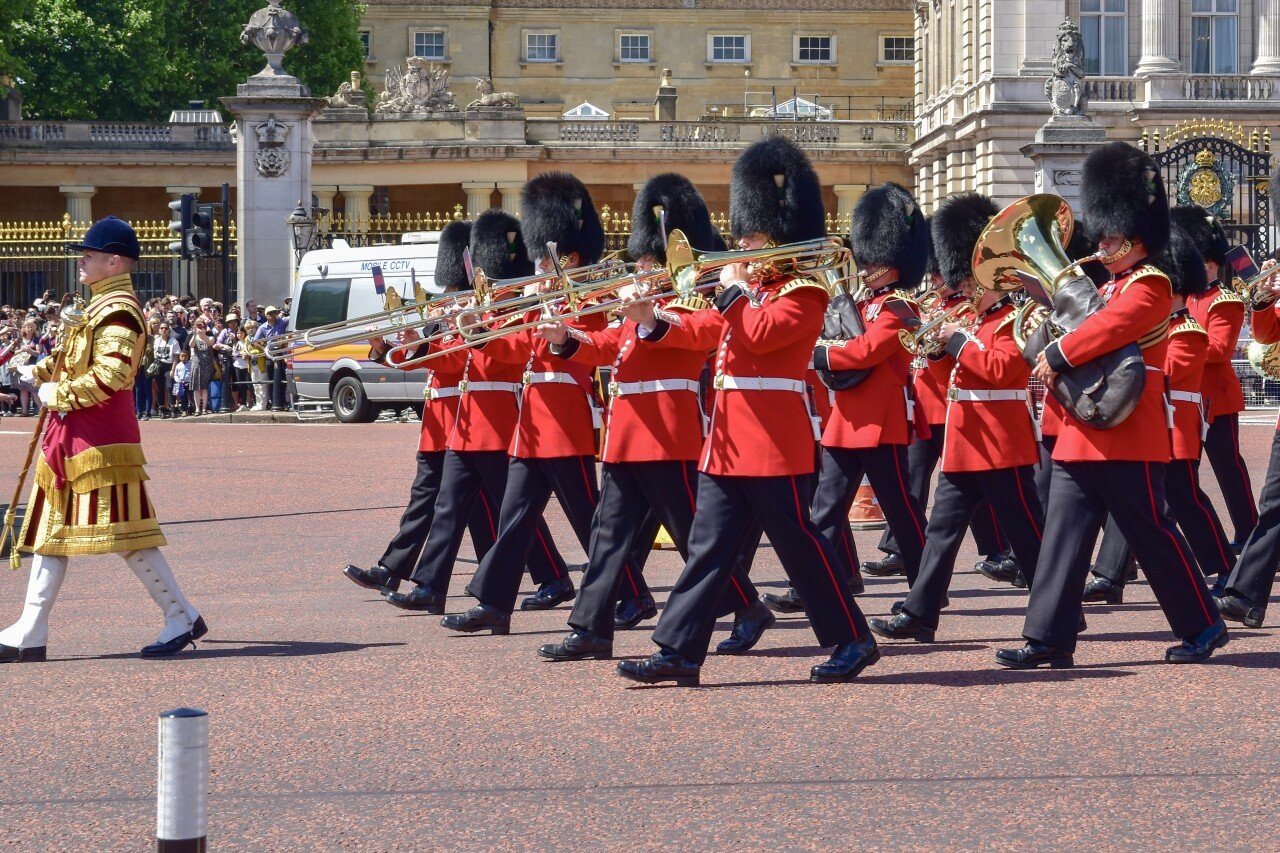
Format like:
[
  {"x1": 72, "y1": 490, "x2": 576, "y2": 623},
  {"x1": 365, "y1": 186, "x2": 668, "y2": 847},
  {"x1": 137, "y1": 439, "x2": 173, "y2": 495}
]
[{"x1": 221, "y1": 0, "x2": 328, "y2": 305}]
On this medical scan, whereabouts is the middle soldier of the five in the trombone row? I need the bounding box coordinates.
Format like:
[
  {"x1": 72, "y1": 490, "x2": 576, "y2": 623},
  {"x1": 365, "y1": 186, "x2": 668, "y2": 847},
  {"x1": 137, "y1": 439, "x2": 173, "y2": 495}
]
[{"x1": 440, "y1": 172, "x2": 604, "y2": 634}]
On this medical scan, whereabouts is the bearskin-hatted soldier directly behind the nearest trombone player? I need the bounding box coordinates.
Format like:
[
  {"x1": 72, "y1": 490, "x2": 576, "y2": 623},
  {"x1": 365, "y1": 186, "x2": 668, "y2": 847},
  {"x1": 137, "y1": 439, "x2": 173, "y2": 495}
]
[{"x1": 813, "y1": 183, "x2": 929, "y2": 583}]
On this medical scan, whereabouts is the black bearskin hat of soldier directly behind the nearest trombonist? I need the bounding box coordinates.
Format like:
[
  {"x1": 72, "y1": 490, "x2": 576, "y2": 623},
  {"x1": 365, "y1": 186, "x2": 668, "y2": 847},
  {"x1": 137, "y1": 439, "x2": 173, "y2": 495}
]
[{"x1": 849, "y1": 183, "x2": 945, "y2": 288}]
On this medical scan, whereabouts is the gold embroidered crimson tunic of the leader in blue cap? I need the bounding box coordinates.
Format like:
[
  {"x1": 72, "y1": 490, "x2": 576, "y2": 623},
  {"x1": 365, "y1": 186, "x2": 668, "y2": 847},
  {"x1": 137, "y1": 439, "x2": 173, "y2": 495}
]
[{"x1": 18, "y1": 274, "x2": 165, "y2": 556}]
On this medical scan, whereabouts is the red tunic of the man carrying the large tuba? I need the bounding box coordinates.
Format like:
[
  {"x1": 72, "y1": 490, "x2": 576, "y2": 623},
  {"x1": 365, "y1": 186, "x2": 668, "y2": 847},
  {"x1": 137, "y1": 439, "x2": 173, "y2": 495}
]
[{"x1": 1050, "y1": 265, "x2": 1172, "y2": 462}]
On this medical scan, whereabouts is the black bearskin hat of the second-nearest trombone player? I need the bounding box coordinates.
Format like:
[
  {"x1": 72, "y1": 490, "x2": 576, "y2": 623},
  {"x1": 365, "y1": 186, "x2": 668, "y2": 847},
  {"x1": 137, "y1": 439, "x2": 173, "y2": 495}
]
[{"x1": 627, "y1": 172, "x2": 724, "y2": 264}]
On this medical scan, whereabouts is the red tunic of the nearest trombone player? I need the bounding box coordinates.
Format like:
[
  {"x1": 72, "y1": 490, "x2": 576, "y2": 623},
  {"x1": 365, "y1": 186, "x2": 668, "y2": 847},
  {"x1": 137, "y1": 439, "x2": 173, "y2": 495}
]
[{"x1": 644, "y1": 277, "x2": 828, "y2": 476}]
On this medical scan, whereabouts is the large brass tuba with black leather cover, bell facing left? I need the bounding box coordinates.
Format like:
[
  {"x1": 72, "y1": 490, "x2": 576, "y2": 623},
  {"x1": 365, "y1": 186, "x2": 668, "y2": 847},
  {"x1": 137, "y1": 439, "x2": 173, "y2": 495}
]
[{"x1": 973, "y1": 193, "x2": 1147, "y2": 429}]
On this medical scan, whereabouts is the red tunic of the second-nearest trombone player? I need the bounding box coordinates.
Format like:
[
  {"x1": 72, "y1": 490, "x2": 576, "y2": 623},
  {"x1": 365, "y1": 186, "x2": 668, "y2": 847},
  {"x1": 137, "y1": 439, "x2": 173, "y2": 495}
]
[{"x1": 557, "y1": 311, "x2": 710, "y2": 462}]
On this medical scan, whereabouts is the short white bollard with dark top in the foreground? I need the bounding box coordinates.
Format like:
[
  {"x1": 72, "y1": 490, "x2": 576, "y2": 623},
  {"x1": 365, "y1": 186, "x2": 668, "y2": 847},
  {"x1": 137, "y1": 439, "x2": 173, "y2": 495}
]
[{"x1": 156, "y1": 708, "x2": 209, "y2": 853}]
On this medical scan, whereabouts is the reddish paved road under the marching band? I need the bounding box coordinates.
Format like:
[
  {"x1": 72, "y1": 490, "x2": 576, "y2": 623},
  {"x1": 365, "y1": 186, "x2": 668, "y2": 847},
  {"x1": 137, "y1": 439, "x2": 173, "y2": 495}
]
[{"x1": 0, "y1": 419, "x2": 1280, "y2": 850}]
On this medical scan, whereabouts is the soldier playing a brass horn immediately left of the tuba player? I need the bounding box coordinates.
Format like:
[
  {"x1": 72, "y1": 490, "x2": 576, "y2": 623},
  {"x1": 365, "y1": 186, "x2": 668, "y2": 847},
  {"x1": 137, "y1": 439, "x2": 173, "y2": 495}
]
[{"x1": 870, "y1": 193, "x2": 1044, "y2": 643}]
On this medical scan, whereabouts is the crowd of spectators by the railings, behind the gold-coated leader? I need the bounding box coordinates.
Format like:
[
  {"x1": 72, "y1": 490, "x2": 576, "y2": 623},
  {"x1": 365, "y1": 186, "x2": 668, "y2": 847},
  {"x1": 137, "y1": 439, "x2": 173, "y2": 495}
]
[{"x1": 0, "y1": 291, "x2": 291, "y2": 420}]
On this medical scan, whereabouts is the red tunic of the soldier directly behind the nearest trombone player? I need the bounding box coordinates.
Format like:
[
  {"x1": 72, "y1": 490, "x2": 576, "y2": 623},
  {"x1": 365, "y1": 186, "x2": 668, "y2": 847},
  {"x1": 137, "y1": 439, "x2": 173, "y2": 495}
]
[{"x1": 813, "y1": 288, "x2": 916, "y2": 448}]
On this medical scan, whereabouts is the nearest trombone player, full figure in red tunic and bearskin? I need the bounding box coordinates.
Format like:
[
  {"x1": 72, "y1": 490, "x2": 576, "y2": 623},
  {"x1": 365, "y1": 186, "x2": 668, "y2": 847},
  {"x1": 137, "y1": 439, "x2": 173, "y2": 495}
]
[{"x1": 618, "y1": 136, "x2": 879, "y2": 685}]
